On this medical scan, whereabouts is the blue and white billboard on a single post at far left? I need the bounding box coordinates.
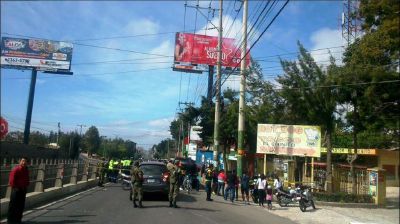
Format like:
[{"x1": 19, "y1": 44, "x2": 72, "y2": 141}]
[{"x1": 1, "y1": 37, "x2": 73, "y2": 72}]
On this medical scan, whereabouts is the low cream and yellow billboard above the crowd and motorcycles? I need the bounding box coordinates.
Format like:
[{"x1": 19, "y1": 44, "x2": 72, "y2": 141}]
[{"x1": 257, "y1": 124, "x2": 321, "y2": 157}]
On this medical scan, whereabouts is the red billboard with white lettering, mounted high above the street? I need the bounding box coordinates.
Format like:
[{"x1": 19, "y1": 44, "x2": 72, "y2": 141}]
[{"x1": 174, "y1": 33, "x2": 250, "y2": 68}]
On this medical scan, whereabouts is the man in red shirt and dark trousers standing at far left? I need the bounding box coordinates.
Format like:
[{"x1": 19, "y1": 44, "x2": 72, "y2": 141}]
[{"x1": 7, "y1": 157, "x2": 29, "y2": 223}]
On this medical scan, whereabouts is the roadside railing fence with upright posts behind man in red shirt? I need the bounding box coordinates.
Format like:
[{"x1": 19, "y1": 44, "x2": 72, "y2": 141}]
[{"x1": 0, "y1": 159, "x2": 97, "y2": 198}]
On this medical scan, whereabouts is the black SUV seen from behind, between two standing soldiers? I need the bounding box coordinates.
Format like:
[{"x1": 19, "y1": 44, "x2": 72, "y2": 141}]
[{"x1": 140, "y1": 161, "x2": 169, "y2": 195}]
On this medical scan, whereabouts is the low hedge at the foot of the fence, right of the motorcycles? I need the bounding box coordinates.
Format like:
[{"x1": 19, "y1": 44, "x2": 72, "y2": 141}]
[{"x1": 313, "y1": 192, "x2": 374, "y2": 203}]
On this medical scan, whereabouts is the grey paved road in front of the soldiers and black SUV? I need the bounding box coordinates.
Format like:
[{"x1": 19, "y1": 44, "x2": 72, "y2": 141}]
[{"x1": 13, "y1": 184, "x2": 293, "y2": 224}]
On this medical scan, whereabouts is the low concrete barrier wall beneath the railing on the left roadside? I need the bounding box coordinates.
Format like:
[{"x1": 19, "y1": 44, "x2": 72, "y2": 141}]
[{"x1": 0, "y1": 179, "x2": 97, "y2": 217}]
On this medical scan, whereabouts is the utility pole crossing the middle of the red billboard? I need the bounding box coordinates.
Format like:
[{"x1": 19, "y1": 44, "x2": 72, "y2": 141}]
[{"x1": 213, "y1": 0, "x2": 223, "y2": 166}]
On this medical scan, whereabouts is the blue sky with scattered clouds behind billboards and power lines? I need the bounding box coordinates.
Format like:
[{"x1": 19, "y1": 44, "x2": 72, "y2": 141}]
[{"x1": 1, "y1": 0, "x2": 343, "y2": 149}]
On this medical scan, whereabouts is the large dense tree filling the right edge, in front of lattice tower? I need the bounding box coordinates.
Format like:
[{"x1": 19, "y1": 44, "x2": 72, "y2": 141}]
[{"x1": 337, "y1": 0, "x2": 400, "y2": 193}]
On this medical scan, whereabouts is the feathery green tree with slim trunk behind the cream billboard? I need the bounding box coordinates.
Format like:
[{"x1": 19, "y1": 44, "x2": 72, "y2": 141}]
[{"x1": 277, "y1": 43, "x2": 337, "y2": 192}]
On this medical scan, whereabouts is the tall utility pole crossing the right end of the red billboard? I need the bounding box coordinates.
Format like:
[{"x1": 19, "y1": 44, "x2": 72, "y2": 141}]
[{"x1": 237, "y1": 0, "x2": 248, "y2": 177}]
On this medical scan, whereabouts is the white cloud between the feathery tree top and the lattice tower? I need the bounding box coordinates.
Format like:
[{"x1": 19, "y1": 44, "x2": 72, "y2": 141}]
[{"x1": 310, "y1": 28, "x2": 343, "y2": 65}]
